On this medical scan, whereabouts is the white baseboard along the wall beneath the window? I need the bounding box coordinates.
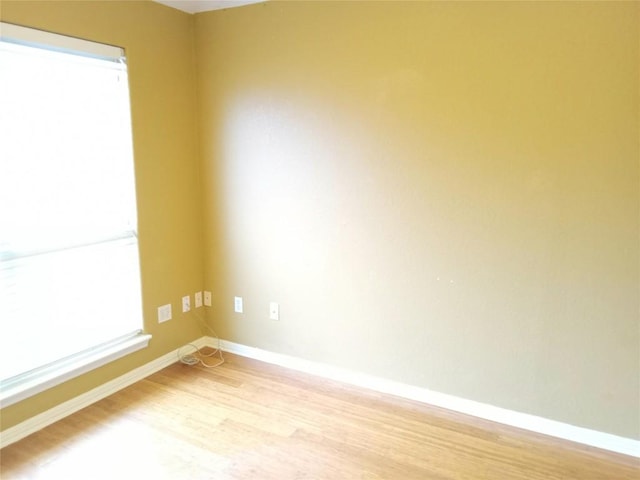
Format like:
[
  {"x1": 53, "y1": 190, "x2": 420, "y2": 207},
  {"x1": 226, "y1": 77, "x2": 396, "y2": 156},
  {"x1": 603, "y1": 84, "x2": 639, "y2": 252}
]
[{"x1": 0, "y1": 337, "x2": 211, "y2": 448}]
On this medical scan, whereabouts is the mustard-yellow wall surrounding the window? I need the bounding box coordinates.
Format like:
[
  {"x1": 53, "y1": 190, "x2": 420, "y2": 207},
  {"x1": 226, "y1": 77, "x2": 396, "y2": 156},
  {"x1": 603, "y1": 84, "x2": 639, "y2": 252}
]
[{"x1": 0, "y1": 0, "x2": 203, "y2": 429}]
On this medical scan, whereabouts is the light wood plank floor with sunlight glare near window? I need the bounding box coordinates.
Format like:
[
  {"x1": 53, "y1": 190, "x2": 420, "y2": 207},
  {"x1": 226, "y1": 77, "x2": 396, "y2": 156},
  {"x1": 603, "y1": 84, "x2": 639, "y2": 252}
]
[{"x1": 0, "y1": 354, "x2": 640, "y2": 480}]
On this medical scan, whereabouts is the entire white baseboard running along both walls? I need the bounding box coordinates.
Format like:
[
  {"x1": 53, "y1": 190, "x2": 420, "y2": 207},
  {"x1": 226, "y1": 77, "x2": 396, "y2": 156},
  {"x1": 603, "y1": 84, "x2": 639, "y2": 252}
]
[{"x1": 0, "y1": 337, "x2": 640, "y2": 458}]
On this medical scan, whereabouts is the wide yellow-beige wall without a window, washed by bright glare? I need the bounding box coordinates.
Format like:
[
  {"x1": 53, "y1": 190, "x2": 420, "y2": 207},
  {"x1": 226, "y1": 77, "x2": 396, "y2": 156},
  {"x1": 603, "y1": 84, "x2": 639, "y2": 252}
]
[{"x1": 196, "y1": 2, "x2": 640, "y2": 439}]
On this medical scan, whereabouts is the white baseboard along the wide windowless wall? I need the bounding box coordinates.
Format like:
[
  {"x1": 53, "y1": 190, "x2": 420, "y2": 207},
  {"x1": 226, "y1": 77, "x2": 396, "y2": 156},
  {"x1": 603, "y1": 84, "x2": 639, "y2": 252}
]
[{"x1": 218, "y1": 337, "x2": 640, "y2": 458}]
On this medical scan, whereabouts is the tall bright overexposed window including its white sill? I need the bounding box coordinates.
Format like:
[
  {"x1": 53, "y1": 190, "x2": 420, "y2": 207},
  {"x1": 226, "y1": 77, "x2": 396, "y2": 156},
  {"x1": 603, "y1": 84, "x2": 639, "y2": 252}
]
[{"x1": 0, "y1": 23, "x2": 150, "y2": 406}]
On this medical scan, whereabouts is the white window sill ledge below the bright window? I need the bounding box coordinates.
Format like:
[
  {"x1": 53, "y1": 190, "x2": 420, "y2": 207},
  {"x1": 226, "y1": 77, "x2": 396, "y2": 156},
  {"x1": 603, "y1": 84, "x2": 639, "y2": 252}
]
[{"x1": 0, "y1": 333, "x2": 151, "y2": 408}]
